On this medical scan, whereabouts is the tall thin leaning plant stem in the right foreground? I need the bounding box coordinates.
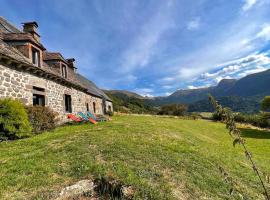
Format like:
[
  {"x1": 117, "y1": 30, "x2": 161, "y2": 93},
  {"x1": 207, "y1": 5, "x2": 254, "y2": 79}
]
[{"x1": 209, "y1": 95, "x2": 270, "y2": 200}]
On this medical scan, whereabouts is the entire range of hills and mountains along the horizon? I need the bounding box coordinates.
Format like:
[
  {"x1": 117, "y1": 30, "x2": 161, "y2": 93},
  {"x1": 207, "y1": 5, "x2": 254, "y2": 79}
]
[{"x1": 105, "y1": 70, "x2": 270, "y2": 112}]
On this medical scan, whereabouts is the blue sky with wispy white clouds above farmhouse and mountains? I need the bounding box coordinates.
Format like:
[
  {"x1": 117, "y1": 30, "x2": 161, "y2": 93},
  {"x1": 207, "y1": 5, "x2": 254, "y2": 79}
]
[{"x1": 0, "y1": 0, "x2": 270, "y2": 96}]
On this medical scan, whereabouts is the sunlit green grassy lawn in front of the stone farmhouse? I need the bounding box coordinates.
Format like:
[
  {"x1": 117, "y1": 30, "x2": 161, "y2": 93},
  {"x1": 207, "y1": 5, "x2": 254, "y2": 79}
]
[{"x1": 0, "y1": 116, "x2": 270, "y2": 199}]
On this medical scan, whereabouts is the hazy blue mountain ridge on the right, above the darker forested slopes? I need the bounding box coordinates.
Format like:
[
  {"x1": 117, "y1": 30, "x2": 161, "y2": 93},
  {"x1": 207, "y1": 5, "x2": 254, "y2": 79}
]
[{"x1": 153, "y1": 70, "x2": 270, "y2": 105}]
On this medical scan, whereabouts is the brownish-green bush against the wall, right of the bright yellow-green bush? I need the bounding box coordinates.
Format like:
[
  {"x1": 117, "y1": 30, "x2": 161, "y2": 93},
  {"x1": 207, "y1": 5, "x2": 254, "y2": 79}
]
[{"x1": 26, "y1": 106, "x2": 58, "y2": 133}]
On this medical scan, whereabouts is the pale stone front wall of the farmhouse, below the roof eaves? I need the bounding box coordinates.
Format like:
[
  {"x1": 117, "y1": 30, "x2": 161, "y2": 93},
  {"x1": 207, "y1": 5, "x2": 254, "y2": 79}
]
[{"x1": 0, "y1": 64, "x2": 103, "y2": 119}]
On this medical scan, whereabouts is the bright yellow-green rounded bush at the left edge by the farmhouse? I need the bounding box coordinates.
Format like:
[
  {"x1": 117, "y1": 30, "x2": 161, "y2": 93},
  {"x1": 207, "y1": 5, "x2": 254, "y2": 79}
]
[{"x1": 0, "y1": 99, "x2": 32, "y2": 140}]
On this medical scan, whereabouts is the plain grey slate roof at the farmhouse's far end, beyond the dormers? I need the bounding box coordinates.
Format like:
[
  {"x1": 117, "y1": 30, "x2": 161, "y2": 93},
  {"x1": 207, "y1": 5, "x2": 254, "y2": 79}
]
[{"x1": 77, "y1": 74, "x2": 112, "y2": 101}]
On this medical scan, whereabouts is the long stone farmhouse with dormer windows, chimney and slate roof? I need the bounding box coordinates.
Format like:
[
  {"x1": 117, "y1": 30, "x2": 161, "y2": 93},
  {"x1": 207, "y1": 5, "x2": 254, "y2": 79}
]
[{"x1": 0, "y1": 17, "x2": 113, "y2": 119}]
